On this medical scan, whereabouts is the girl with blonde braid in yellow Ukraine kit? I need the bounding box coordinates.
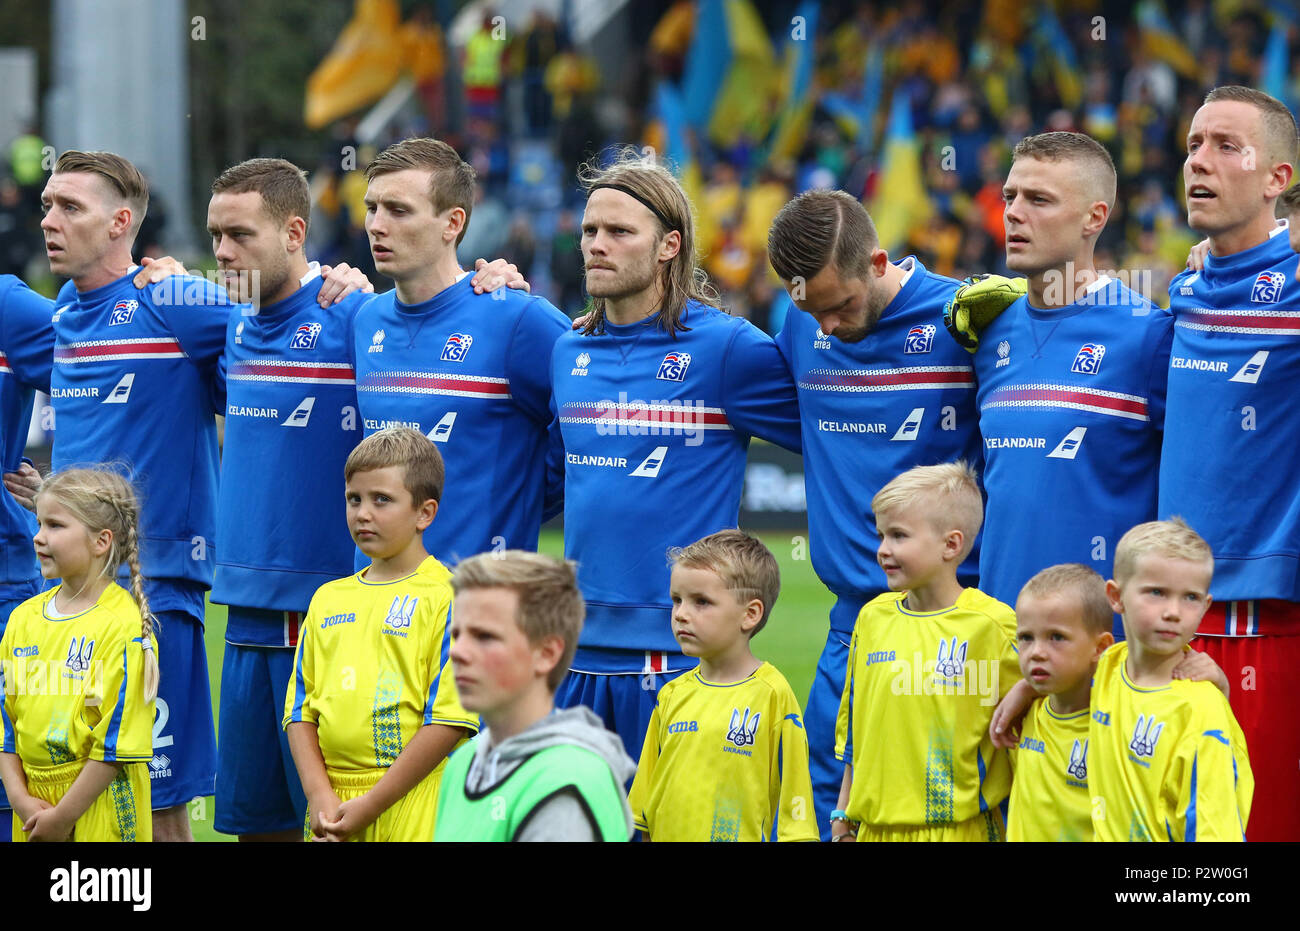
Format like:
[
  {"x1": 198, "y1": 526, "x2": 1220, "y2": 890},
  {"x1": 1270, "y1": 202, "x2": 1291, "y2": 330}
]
[{"x1": 0, "y1": 468, "x2": 159, "y2": 841}]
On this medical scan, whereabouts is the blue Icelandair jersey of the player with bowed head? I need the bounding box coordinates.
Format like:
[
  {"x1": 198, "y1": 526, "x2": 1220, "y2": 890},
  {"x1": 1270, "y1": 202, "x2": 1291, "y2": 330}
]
[{"x1": 776, "y1": 257, "x2": 983, "y2": 621}]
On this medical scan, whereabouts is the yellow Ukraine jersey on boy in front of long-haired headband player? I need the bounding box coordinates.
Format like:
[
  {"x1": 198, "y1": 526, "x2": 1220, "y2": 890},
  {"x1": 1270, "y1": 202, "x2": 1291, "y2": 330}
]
[{"x1": 628, "y1": 663, "x2": 818, "y2": 841}]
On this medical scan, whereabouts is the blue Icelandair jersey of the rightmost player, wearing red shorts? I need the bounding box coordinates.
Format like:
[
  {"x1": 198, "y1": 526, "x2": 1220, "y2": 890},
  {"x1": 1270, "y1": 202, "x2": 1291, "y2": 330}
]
[{"x1": 1160, "y1": 222, "x2": 1300, "y2": 603}]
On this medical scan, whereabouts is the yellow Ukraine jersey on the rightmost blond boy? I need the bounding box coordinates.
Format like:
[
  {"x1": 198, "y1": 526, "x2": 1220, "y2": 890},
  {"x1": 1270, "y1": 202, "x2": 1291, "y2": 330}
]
[{"x1": 1088, "y1": 642, "x2": 1255, "y2": 841}]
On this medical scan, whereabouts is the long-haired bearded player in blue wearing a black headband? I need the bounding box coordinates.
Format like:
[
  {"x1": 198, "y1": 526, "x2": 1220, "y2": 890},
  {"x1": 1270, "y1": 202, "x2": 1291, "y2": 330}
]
[{"x1": 551, "y1": 151, "x2": 800, "y2": 757}]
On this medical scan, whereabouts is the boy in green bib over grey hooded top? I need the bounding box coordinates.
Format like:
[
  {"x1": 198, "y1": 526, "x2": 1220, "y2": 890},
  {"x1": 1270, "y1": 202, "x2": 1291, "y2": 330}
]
[{"x1": 434, "y1": 550, "x2": 636, "y2": 841}]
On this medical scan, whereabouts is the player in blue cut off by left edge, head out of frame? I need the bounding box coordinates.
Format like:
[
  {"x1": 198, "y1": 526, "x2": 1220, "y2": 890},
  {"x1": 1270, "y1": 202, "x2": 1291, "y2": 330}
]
[{"x1": 0, "y1": 274, "x2": 55, "y2": 841}]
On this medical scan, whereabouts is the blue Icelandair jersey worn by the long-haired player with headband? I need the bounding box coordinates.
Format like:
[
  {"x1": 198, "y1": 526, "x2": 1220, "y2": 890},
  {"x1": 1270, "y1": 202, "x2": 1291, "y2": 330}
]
[{"x1": 551, "y1": 302, "x2": 801, "y2": 672}]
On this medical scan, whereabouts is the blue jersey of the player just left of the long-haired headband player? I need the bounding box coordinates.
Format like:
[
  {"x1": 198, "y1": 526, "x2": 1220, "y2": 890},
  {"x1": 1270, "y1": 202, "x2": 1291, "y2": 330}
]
[{"x1": 355, "y1": 274, "x2": 569, "y2": 568}]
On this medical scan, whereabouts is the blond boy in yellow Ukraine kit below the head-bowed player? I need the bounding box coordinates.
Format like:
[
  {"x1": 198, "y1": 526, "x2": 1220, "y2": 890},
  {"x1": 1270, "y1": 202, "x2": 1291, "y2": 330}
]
[{"x1": 831, "y1": 463, "x2": 1019, "y2": 841}]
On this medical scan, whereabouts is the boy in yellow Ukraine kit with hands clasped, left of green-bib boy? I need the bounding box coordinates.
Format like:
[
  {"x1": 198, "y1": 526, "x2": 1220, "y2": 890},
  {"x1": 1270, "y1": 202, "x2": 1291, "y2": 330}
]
[{"x1": 285, "y1": 428, "x2": 478, "y2": 840}]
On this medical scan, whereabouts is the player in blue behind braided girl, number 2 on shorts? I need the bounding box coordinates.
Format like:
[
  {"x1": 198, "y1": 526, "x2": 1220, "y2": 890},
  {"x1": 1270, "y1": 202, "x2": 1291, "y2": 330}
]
[{"x1": 40, "y1": 151, "x2": 231, "y2": 840}]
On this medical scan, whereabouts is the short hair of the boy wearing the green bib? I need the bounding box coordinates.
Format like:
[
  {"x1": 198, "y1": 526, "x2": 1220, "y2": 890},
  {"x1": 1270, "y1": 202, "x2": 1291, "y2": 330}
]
[{"x1": 451, "y1": 550, "x2": 586, "y2": 693}]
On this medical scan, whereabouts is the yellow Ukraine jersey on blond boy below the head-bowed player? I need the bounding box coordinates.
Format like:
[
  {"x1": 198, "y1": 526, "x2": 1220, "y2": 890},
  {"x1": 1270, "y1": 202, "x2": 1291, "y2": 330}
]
[{"x1": 835, "y1": 588, "x2": 1021, "y2": 826}]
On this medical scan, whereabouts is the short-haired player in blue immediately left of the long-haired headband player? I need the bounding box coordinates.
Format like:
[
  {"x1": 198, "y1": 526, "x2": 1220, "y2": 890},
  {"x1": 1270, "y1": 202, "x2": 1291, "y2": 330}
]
[{"x1": 355, "y1": 138, "x2": 569, "y2": 568}]
